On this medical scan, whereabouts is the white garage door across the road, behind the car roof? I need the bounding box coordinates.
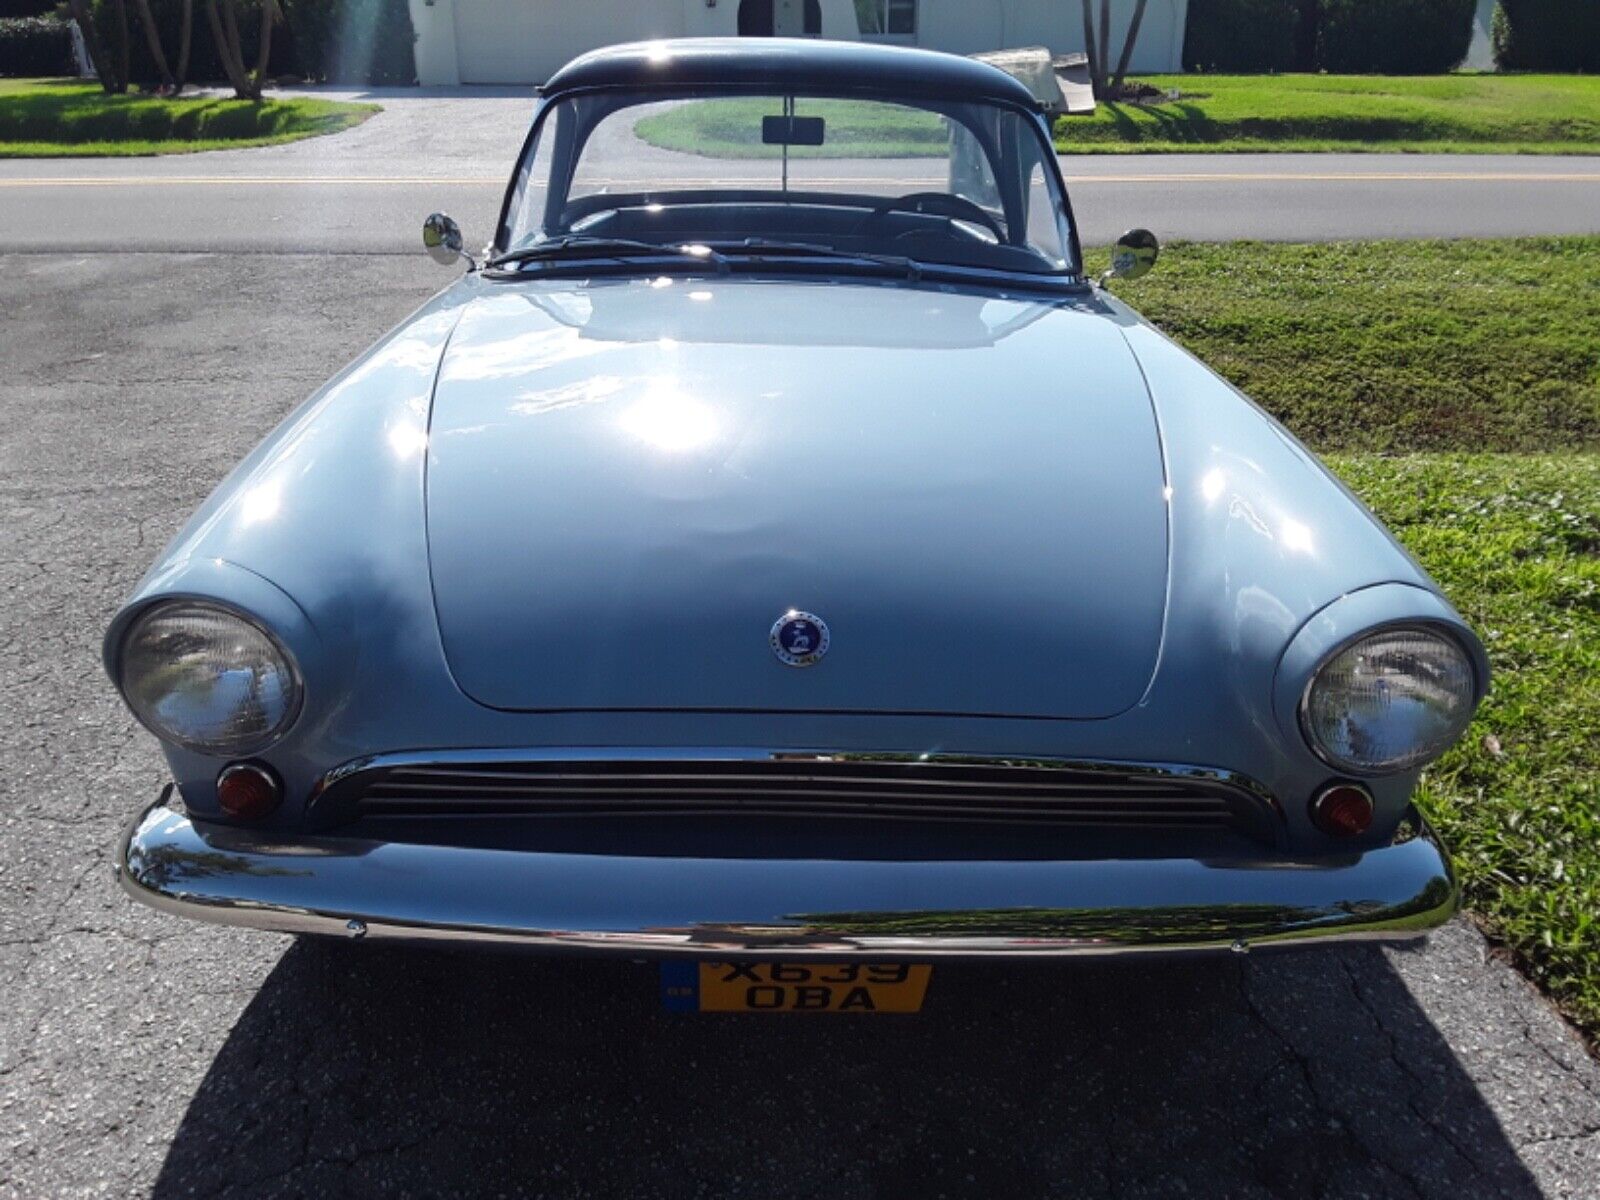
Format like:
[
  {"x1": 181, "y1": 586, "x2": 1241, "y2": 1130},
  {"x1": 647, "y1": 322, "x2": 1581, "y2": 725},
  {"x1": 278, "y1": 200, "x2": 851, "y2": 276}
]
[{"x1": 454, "y1": 0, "x2": 683, "y2": 83}]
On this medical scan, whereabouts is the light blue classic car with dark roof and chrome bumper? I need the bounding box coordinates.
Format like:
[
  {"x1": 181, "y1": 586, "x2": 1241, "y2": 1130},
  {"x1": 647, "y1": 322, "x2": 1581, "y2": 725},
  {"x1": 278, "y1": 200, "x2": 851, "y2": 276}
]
[{"x1": 106, "y1": 40, "x2": 1488, "y2": 1006}]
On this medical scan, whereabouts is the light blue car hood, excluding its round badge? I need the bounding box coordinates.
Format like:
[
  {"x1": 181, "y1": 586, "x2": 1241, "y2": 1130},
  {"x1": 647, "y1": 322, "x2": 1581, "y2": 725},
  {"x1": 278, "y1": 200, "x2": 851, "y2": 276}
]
[{"x1": 427, "y1": 278, "x2": 1168, "y2": 718}]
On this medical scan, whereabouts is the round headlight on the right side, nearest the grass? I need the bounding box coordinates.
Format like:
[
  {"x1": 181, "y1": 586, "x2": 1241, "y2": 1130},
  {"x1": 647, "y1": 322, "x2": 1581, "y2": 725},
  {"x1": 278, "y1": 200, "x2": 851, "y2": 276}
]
[{"x1": 1301, "y1": 629, "x2": 1477, "y2": 774}]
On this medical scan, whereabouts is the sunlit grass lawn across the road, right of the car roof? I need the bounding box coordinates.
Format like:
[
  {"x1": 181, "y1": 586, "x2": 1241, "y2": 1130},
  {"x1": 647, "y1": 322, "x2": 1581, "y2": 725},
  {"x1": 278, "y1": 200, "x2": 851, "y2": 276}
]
[{"x1": 1056, "y1": 74, "x2": 1600, "y2": 154}]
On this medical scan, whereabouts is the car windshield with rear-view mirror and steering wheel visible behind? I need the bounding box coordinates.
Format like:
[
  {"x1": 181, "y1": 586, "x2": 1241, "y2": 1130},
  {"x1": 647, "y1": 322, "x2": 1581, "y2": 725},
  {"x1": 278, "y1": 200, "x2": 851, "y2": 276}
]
[{"x1": 496, "y1": 88, "x2": 1077, "y2": 277}]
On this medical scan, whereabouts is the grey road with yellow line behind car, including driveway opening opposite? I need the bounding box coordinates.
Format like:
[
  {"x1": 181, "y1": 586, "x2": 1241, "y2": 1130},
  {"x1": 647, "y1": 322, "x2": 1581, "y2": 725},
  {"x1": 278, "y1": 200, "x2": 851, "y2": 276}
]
[{"x1": 0, "y1": 88, "x2": 1600, "y2": 253}]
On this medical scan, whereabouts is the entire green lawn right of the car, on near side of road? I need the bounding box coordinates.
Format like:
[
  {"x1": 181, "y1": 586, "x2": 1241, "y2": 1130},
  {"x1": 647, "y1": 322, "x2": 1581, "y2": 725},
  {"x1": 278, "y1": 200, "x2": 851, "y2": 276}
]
[{"x1": 1093, "y1": 237, "x2": 1600, "y2": 1037}]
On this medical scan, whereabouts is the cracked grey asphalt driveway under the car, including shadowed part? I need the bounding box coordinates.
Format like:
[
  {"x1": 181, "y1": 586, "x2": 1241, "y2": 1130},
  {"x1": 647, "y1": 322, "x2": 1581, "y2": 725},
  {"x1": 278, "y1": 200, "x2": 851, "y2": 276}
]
[{"x1": 0, "y1": 254, "x2": 1600, "y2": 1200}]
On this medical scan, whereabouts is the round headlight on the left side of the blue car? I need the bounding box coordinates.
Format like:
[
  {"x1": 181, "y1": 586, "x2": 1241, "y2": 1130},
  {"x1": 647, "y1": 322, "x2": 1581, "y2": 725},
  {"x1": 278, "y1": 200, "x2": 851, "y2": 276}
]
[{"x1": 118, "y1": 600, "x2": 301, "y2": 757}]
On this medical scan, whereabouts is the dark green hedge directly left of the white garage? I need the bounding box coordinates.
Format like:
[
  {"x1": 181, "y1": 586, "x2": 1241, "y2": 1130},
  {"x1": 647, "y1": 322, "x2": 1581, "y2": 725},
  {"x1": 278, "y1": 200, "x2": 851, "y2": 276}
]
[{"x1": 283, "y1": 0, "x2": 416, "y2": 85}]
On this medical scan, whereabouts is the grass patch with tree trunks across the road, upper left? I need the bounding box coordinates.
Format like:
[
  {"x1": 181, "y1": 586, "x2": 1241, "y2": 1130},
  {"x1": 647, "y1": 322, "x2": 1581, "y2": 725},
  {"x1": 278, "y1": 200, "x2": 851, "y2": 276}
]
[{"x1": 0, "y1": 80, "x2": 378, "y2": 158}]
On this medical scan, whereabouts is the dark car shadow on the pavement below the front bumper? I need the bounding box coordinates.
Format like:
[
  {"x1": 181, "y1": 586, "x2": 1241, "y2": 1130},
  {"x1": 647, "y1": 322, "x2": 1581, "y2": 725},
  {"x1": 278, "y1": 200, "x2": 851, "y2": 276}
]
[{"x1": 155, "y1": 941, "x2": 1538, "y2": 1200}]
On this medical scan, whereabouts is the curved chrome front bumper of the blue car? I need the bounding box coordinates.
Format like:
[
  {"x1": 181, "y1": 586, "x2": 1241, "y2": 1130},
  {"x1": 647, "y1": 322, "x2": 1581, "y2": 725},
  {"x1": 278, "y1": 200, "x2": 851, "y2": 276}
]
[{"x1": 117, "y1": 794, "x2": 1458, "y2": 958}]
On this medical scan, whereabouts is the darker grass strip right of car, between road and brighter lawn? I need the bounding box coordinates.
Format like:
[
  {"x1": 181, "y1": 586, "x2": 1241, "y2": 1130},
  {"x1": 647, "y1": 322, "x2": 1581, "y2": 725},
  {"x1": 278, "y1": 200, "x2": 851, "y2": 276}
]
[{"x1": 1115, "y1": 237, "x2": 1600, "y2": 451}]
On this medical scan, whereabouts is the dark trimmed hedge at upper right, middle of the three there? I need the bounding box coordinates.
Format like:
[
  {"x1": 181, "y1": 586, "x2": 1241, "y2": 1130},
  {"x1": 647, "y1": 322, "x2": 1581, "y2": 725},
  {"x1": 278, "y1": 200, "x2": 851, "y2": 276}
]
[{"x1": 1317, "y1": 0, "x2": 1472, "y2": 75}]
